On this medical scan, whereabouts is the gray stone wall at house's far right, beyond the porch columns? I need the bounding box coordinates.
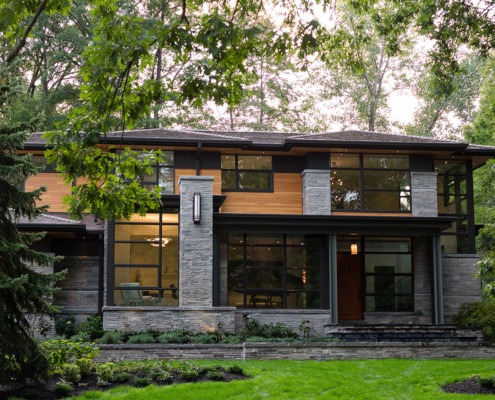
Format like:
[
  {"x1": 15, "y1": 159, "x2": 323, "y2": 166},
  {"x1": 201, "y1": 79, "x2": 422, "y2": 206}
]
[{"x1": 442, "y1": 254, "x2": 481, "y2": 323}]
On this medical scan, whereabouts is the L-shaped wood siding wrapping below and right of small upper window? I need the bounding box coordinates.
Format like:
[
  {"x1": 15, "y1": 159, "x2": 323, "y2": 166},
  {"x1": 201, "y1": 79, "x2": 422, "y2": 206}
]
[{"x1": 221, "y1": 173, "x2": 302, "y2": 214}]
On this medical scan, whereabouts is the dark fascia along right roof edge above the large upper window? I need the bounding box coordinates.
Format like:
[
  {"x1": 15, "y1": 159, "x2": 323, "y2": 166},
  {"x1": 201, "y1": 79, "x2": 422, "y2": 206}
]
[{"x1": 284, "y1": 139, "x2": 468, "y2": 151}]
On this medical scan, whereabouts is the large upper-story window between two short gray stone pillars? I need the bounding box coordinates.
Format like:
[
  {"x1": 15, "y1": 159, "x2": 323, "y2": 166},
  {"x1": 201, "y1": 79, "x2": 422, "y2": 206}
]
[{"x1": 330, "y1": 154, "x2": 411, "y2": 212}]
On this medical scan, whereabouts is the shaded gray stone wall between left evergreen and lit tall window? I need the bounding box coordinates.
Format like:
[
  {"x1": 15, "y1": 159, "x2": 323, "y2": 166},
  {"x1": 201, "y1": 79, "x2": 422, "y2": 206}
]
[{"x1": 53, "y1": 256, "x2": 100, "y2": 322}]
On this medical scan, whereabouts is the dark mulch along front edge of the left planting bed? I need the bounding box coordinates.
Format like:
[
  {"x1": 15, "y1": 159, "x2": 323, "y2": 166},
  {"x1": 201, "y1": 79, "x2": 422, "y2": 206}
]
[{"x1": 0, "y1": 372, "x2": 248, "y2": 400}]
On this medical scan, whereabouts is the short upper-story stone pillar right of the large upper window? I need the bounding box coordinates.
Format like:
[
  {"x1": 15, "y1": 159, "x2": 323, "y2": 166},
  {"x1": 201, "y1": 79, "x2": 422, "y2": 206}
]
[{"x1": 411, "y1": 171, "x2": 438, "y2": 217}]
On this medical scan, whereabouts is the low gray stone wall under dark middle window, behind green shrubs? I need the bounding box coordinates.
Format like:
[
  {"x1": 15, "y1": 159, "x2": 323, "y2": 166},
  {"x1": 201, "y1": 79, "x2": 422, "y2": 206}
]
[{"x1": 235, "y1": 309, "x2": 332, "y2": 336}]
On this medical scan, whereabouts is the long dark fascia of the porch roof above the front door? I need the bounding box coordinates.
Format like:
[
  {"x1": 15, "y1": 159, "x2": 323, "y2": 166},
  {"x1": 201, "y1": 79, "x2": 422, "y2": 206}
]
[{"x1": 213, "y1": 213, "x2": 456, "y2": 236}]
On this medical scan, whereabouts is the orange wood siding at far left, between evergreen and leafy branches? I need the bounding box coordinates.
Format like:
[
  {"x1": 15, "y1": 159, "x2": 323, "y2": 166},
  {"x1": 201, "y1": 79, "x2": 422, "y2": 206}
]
[{"x1": 24, "y1": 173, "x2": 71, "y2": 212}]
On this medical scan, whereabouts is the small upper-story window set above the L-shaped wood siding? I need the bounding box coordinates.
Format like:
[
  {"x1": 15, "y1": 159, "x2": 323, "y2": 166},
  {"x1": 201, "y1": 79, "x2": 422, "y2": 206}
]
[{"x1": 222, "y1": 154, "x2": 273, "y2": 191}]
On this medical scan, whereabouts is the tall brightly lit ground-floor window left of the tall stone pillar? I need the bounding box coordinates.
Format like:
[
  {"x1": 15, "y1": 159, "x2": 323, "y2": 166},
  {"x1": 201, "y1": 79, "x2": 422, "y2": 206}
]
[{"x1": 109, "y1": 210, "x2": 179, "y2": 306}]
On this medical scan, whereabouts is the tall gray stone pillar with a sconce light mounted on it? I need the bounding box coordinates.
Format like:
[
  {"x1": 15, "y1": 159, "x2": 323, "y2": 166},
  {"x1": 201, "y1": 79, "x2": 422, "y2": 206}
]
[{"x1": 179, "y1": 176, "x2": 213, "y2": 307}]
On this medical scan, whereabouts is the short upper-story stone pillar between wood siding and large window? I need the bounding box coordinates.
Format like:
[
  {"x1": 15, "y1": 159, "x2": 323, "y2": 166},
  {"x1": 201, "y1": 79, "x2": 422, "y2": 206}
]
[{"x1": 301, "y1": 169, "x2": 332, "y2": 215}]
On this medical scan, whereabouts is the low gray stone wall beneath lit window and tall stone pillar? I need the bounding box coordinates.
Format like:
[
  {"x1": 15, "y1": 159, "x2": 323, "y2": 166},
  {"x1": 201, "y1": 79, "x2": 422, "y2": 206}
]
[{"x1": 103, "y1": 307, "x2": 235, "y2": 332}]
